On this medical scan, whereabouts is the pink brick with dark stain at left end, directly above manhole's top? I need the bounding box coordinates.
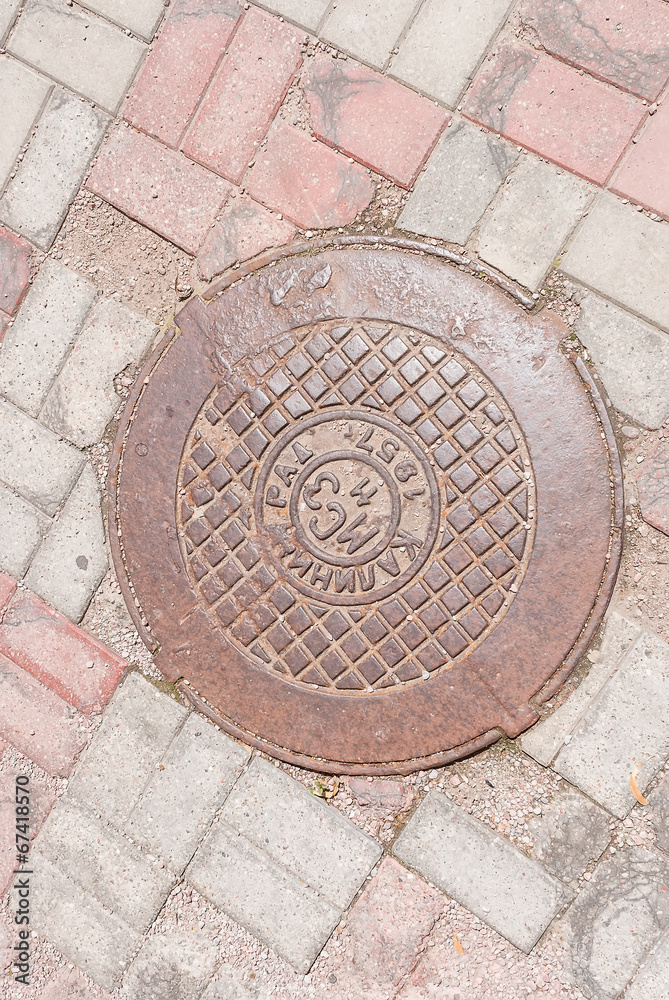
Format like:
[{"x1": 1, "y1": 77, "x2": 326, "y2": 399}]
[{"x1": 303, "y1": 55, "x2": 449, "y2": 188}]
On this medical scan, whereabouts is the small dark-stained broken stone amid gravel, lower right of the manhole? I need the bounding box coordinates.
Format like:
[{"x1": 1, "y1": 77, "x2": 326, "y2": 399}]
[{"x1": 529, "y1": 789, "x2": 611, "y2": 882}]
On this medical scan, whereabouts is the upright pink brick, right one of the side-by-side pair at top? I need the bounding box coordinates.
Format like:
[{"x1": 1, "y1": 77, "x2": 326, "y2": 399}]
[{"x1": 183, "y1": 7, "x2": 306, "y2": 183}]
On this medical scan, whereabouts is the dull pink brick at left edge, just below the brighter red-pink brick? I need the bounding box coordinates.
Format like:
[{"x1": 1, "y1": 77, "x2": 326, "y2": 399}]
[{"x1": 0, "y1": 654, "x2": 85, "y2": 776}]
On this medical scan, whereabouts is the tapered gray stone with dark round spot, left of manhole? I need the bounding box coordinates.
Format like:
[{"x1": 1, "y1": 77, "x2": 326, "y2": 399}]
[{"x1": 26, "y1": 464, "x2": 107, "y2": 622}]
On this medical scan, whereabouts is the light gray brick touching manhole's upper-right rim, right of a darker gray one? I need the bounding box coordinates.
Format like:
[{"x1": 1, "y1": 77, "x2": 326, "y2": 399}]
[{"x1": 478, "y1": 156, "x2": 593, "y2": 291}]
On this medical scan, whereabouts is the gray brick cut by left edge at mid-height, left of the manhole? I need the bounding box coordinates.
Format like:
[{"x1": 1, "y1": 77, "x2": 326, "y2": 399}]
[{"x1": 0, "y1": 399, "x2": 84, "y2": 515}]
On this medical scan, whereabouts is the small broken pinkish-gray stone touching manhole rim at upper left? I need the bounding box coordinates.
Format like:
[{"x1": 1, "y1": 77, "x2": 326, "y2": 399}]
[{"x1": 198, "y1": 192, "x2": 295, "y2": 281}]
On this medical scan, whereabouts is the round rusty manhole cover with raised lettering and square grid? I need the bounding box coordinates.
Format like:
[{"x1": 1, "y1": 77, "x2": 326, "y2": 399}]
[{"x1": 112, "y1": 240, "x2": 620, "y2": 773}]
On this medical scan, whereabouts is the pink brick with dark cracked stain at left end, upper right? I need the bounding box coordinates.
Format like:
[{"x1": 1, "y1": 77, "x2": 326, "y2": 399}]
[{"x1": 465, "y1": 46, "x2": 645, "y2": 184}]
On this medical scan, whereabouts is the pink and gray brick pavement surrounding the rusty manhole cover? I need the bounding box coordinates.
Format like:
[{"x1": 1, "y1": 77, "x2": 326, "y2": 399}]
[{"x1": 0, "y1": 0, "x2": 669, "y2": 1000}]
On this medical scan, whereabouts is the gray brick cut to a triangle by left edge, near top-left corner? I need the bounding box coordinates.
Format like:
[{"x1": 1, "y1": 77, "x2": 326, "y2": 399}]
[{"x1": 0, "y1": 54, "x2": 52, "y2": 189}]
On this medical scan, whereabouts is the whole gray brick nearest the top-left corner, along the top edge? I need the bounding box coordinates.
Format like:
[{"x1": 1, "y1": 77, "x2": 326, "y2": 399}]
[{"x1": 9, "y1": 0, "x2": 146, "y2": 113}]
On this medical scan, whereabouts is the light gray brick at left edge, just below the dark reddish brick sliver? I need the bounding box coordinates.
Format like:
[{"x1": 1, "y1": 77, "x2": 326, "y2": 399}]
[{"x1": 0, "y1": 258, "x2": 97, "y2": 417}]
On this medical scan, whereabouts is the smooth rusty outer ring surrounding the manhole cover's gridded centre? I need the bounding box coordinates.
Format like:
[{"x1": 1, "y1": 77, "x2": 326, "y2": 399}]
[{"x1": 109, "y1": 238, "x2": 623, "y2": 774}]
